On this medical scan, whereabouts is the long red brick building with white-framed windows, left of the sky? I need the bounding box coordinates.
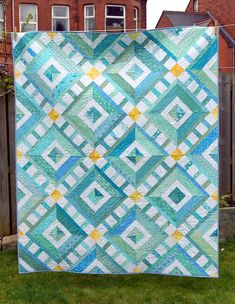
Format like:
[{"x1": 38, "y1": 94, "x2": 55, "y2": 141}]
[{"x1": 0, "y1": 0, "x2": 147, "y2": 72}]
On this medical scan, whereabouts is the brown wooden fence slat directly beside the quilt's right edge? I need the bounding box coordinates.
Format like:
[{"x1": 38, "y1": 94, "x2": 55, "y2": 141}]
[{"x1": 219, "y1": 73, "x2": 232, "y2": 195}]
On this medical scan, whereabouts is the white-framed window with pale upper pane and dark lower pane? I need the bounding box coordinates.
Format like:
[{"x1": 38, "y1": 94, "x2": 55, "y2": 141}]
[{"x1": 52, "y1": 6, "x2": 69, "y2": 32}]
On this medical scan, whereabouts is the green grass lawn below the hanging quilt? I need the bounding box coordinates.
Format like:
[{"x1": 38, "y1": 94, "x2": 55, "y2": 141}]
[{"x1": 0, "y1": 241, "x2": 235, "y2": 304}]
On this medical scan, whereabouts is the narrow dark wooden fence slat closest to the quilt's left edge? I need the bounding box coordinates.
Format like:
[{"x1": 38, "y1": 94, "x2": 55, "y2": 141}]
[{"x1": 7, "y1": 94, "x2": 16, "y2": 234}]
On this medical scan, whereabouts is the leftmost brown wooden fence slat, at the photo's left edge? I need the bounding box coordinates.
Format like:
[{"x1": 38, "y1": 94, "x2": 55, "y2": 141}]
[{"x1": 0, "y1": 97, "x2": 11, "y2": 236}]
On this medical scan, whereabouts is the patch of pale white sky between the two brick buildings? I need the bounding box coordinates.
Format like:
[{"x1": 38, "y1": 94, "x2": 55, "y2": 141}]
[{"x1": 147, "y1": 0, "x2": 189, "y2": 29}]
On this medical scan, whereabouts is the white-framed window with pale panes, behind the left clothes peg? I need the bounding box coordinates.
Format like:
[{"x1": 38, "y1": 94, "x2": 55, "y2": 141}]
[{"x1": 20, "y1": 4, "x2": 38, "y2": 32}]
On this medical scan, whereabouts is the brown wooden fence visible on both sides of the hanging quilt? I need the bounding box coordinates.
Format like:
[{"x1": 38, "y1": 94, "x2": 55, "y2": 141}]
[{"x1": 0, "y1": 73, "x2": 235, "y2": 237}]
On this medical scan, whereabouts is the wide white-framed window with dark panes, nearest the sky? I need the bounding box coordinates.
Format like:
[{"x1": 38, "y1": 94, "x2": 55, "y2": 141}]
[{"x1": 105, "y1": 5, "x2": 126, "y2": 32}]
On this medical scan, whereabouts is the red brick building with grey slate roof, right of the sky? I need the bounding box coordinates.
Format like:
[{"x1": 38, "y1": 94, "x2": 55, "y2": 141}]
[{"x1": 156, "y1": 0, "x2": 235, "y2": 72}]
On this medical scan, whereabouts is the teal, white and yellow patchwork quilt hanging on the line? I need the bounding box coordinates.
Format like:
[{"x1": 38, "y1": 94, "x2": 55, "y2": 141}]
[{"x1": 12, "y1": 27, "x2": 218, "y2": 277}]
